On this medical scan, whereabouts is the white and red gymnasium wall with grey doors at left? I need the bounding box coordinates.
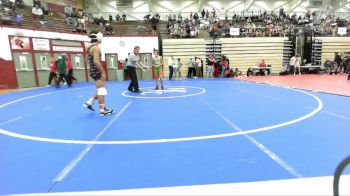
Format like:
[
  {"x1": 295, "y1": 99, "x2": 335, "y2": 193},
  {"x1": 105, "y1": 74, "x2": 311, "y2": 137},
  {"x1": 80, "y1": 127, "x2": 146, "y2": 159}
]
[{"x1": 0, "y1": 26, "x2": 158, "y2": 88}]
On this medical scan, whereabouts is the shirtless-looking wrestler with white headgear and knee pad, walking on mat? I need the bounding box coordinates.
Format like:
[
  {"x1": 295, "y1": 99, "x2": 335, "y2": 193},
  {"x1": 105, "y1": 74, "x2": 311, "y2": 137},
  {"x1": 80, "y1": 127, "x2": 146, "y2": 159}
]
[{"x1": 84, "y1": 31, "x2": 114, "y2": 116}]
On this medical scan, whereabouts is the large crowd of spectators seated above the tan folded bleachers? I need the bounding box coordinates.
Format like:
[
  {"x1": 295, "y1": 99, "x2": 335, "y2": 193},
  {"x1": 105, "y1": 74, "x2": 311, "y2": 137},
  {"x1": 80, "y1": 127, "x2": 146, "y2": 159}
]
[{"x1": 167, "y1": 8, "x2": 350, "y2": 38}]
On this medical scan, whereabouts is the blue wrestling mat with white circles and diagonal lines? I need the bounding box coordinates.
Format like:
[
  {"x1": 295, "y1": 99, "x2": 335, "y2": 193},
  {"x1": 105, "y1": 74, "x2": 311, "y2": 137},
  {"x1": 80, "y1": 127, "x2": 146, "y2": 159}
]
[{"x1": 0, "y1": 79, "x2": 350, "y2": 195}]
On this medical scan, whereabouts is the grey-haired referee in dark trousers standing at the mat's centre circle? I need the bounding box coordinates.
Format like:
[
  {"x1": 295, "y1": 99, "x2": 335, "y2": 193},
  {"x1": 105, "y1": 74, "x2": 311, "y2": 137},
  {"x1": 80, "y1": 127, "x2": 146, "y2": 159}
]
[{"x1": 126, "y1": 46, "x2": 148, "y2": 93}]
